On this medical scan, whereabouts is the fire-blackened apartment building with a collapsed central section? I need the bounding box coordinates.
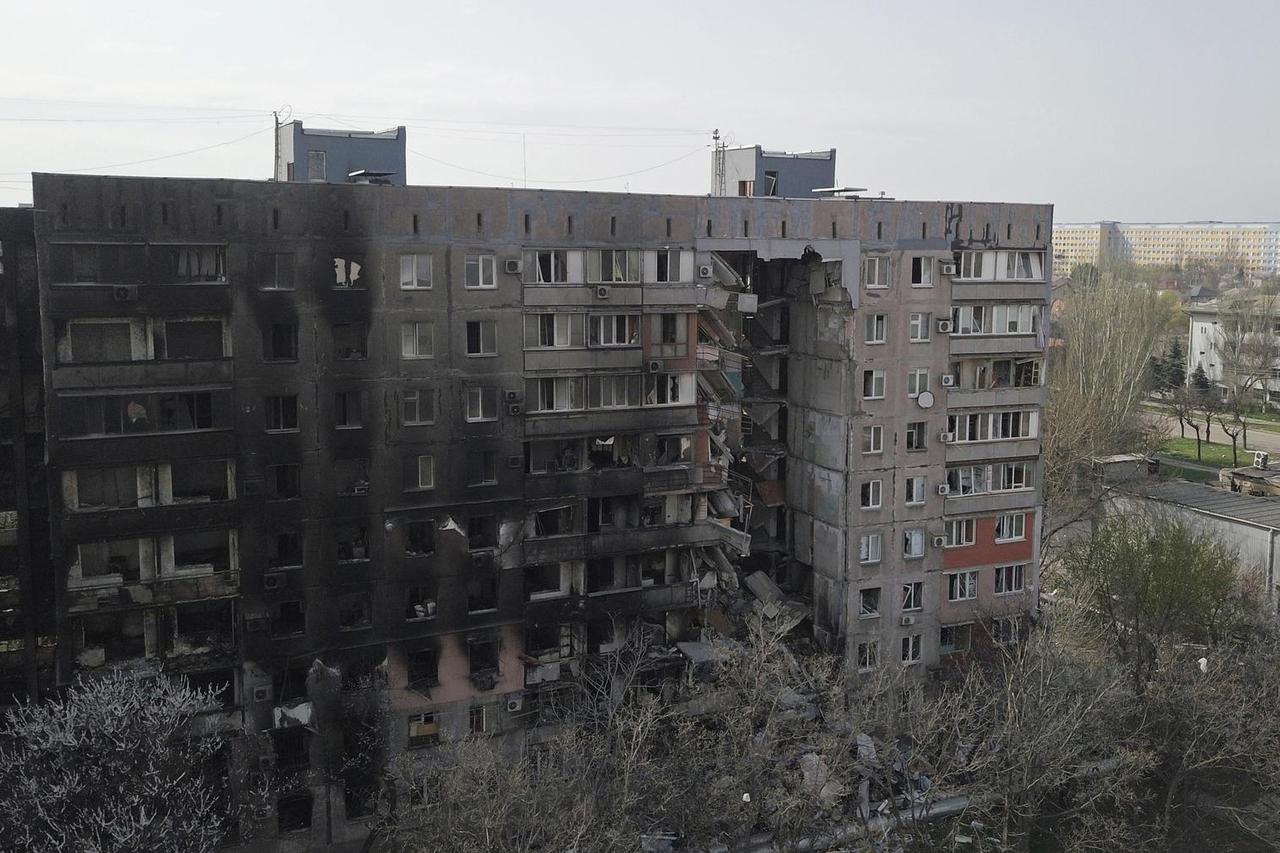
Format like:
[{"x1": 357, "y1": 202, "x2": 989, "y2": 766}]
[{"x1": 6, "y1": 162, "x2": 1051, "y2": 850}]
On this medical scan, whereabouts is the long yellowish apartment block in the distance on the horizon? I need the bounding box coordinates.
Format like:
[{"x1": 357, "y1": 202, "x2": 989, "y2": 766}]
[{"x1": 1053, "y1": 222, "x2": 1280, "y2": 275}]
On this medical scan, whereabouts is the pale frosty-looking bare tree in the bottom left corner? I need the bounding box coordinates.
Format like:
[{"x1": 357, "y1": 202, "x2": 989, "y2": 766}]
[{"x1": 0, "y1": 671, "x2": 230, "y2": 853}]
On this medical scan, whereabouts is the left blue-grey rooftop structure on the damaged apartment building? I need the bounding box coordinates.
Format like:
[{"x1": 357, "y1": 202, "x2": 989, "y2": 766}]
[{"x1": 275, "y1": 122, "x2": 406, "y2": 187}]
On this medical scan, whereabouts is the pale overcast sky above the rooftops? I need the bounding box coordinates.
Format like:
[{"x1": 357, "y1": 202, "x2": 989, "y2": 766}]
[{"x1": 0, "y1": 0, "x2": 1280, "y2": 222}]
